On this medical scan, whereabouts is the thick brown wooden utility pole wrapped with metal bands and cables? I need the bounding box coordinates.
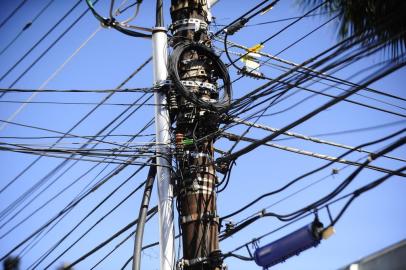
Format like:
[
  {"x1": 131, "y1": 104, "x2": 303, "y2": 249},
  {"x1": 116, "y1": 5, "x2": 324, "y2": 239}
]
[{"x1": 168, "y1": 0, "x2": 231, "y2": 270}]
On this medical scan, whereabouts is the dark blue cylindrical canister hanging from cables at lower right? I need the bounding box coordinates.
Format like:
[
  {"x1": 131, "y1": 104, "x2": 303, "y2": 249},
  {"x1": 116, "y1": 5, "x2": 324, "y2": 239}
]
[{"x1": 254, "y1": 220, "x2": 323, "y2": 268}]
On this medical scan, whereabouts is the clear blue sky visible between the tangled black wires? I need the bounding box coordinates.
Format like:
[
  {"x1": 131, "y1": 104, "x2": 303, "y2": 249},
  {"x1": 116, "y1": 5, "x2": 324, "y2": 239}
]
[{"x1": 0, "y1": 0, "x2": 406, "y2": 270}]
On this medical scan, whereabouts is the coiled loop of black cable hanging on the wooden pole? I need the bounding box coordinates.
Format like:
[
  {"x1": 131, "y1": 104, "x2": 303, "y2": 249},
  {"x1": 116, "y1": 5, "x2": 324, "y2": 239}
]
[{"x1": 169, "y1": 42, "x2": 232, "y2": 113}]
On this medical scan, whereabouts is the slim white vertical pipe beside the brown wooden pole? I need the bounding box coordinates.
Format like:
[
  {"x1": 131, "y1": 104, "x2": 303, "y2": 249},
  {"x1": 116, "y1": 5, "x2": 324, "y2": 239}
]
[{"x1": 152, "y1": 27, "x2": 175, "y2": 270}]
